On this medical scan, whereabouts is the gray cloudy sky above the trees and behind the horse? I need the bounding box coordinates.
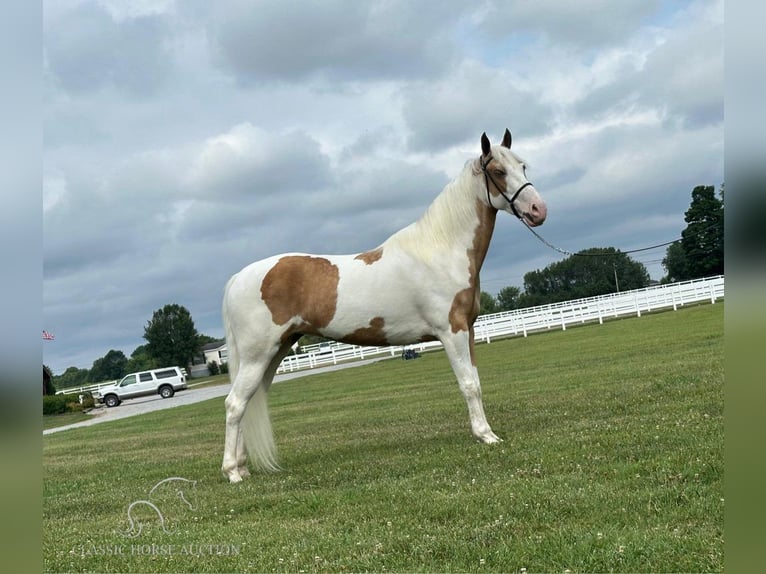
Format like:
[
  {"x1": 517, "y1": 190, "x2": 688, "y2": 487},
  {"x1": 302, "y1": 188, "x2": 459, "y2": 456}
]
[{"x1": 43, "y1": 0, "x2": 724, "y2": 374}]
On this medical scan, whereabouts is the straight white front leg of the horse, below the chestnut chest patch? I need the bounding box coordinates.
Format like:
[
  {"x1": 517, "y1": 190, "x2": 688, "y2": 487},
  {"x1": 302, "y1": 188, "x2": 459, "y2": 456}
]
[{"x1": 440, "y1": 329, "x2": 502, "y2": 444}]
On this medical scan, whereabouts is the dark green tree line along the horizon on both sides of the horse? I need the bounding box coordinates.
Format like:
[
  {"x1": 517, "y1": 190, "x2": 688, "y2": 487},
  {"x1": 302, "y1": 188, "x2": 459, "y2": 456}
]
[{"x1": 53, "y1": 185, "x2": 724, "y2": 389}]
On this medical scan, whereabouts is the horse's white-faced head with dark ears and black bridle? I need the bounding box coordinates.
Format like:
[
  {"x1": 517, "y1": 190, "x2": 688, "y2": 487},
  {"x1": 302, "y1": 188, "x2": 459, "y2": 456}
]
[{"x1": 479, "y1": 129, "x2": 548, "y2": 227}]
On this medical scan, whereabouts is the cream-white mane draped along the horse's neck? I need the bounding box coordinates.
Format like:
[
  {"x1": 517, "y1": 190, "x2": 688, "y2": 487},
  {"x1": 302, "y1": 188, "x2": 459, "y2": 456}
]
[{"x1": 382, "y1": 160, "x2": 478, "y2": 261}]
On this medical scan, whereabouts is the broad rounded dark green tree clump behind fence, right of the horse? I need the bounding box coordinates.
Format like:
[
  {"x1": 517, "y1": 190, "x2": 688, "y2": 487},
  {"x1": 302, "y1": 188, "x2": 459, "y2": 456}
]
[{"x1": 519, "y1": 247, "x2": 650, "y2": 307}]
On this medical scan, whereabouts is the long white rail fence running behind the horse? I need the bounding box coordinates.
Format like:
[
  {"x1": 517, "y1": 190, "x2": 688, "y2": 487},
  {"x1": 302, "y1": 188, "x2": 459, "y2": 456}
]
[{"x1": 59, "y1": 275, "x2": 724, "y2": 393}]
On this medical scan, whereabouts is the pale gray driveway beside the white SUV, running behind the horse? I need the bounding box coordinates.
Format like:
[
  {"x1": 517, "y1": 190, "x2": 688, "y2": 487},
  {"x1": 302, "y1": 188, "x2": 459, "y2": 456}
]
[{"x1": 43, "y1": 357, "x2": 390, "y2": 435}]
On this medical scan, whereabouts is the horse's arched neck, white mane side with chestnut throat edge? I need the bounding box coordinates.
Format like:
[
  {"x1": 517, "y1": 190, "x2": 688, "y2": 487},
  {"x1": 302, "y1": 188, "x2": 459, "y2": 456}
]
[{"x1": 384, "y1": 165, "x2": 497, "y2": 274}]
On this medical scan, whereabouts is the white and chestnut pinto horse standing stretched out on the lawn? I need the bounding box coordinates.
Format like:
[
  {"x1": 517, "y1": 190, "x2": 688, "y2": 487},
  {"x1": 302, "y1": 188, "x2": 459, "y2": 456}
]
[{"x1": 221, "y1": 129, "x2": 547, "y2": 483}]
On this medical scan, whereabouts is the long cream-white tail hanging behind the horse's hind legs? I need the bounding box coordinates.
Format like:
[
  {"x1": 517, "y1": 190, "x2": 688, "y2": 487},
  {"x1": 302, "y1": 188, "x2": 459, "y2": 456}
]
[{"x1": 222, "y1": 275, "x2": 280, "y2": 471}]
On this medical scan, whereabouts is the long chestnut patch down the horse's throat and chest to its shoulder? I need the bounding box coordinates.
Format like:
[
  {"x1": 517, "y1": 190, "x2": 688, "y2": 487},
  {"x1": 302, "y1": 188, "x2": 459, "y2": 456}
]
[{"x1": 449, "y1": 199, "x2": 497, "y2": 360}]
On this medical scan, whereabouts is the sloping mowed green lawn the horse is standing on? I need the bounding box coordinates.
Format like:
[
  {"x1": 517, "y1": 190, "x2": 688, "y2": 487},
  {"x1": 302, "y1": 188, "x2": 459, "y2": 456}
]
[{"x1": 43, "y1": 302, "x2": 724, "y2": 573}]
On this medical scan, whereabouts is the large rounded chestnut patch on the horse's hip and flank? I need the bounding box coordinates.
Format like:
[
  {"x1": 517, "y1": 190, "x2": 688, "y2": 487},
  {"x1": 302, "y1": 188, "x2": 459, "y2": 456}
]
[{"x1": 261, "y1": 255, "x2": 339, "y2": 332}]
